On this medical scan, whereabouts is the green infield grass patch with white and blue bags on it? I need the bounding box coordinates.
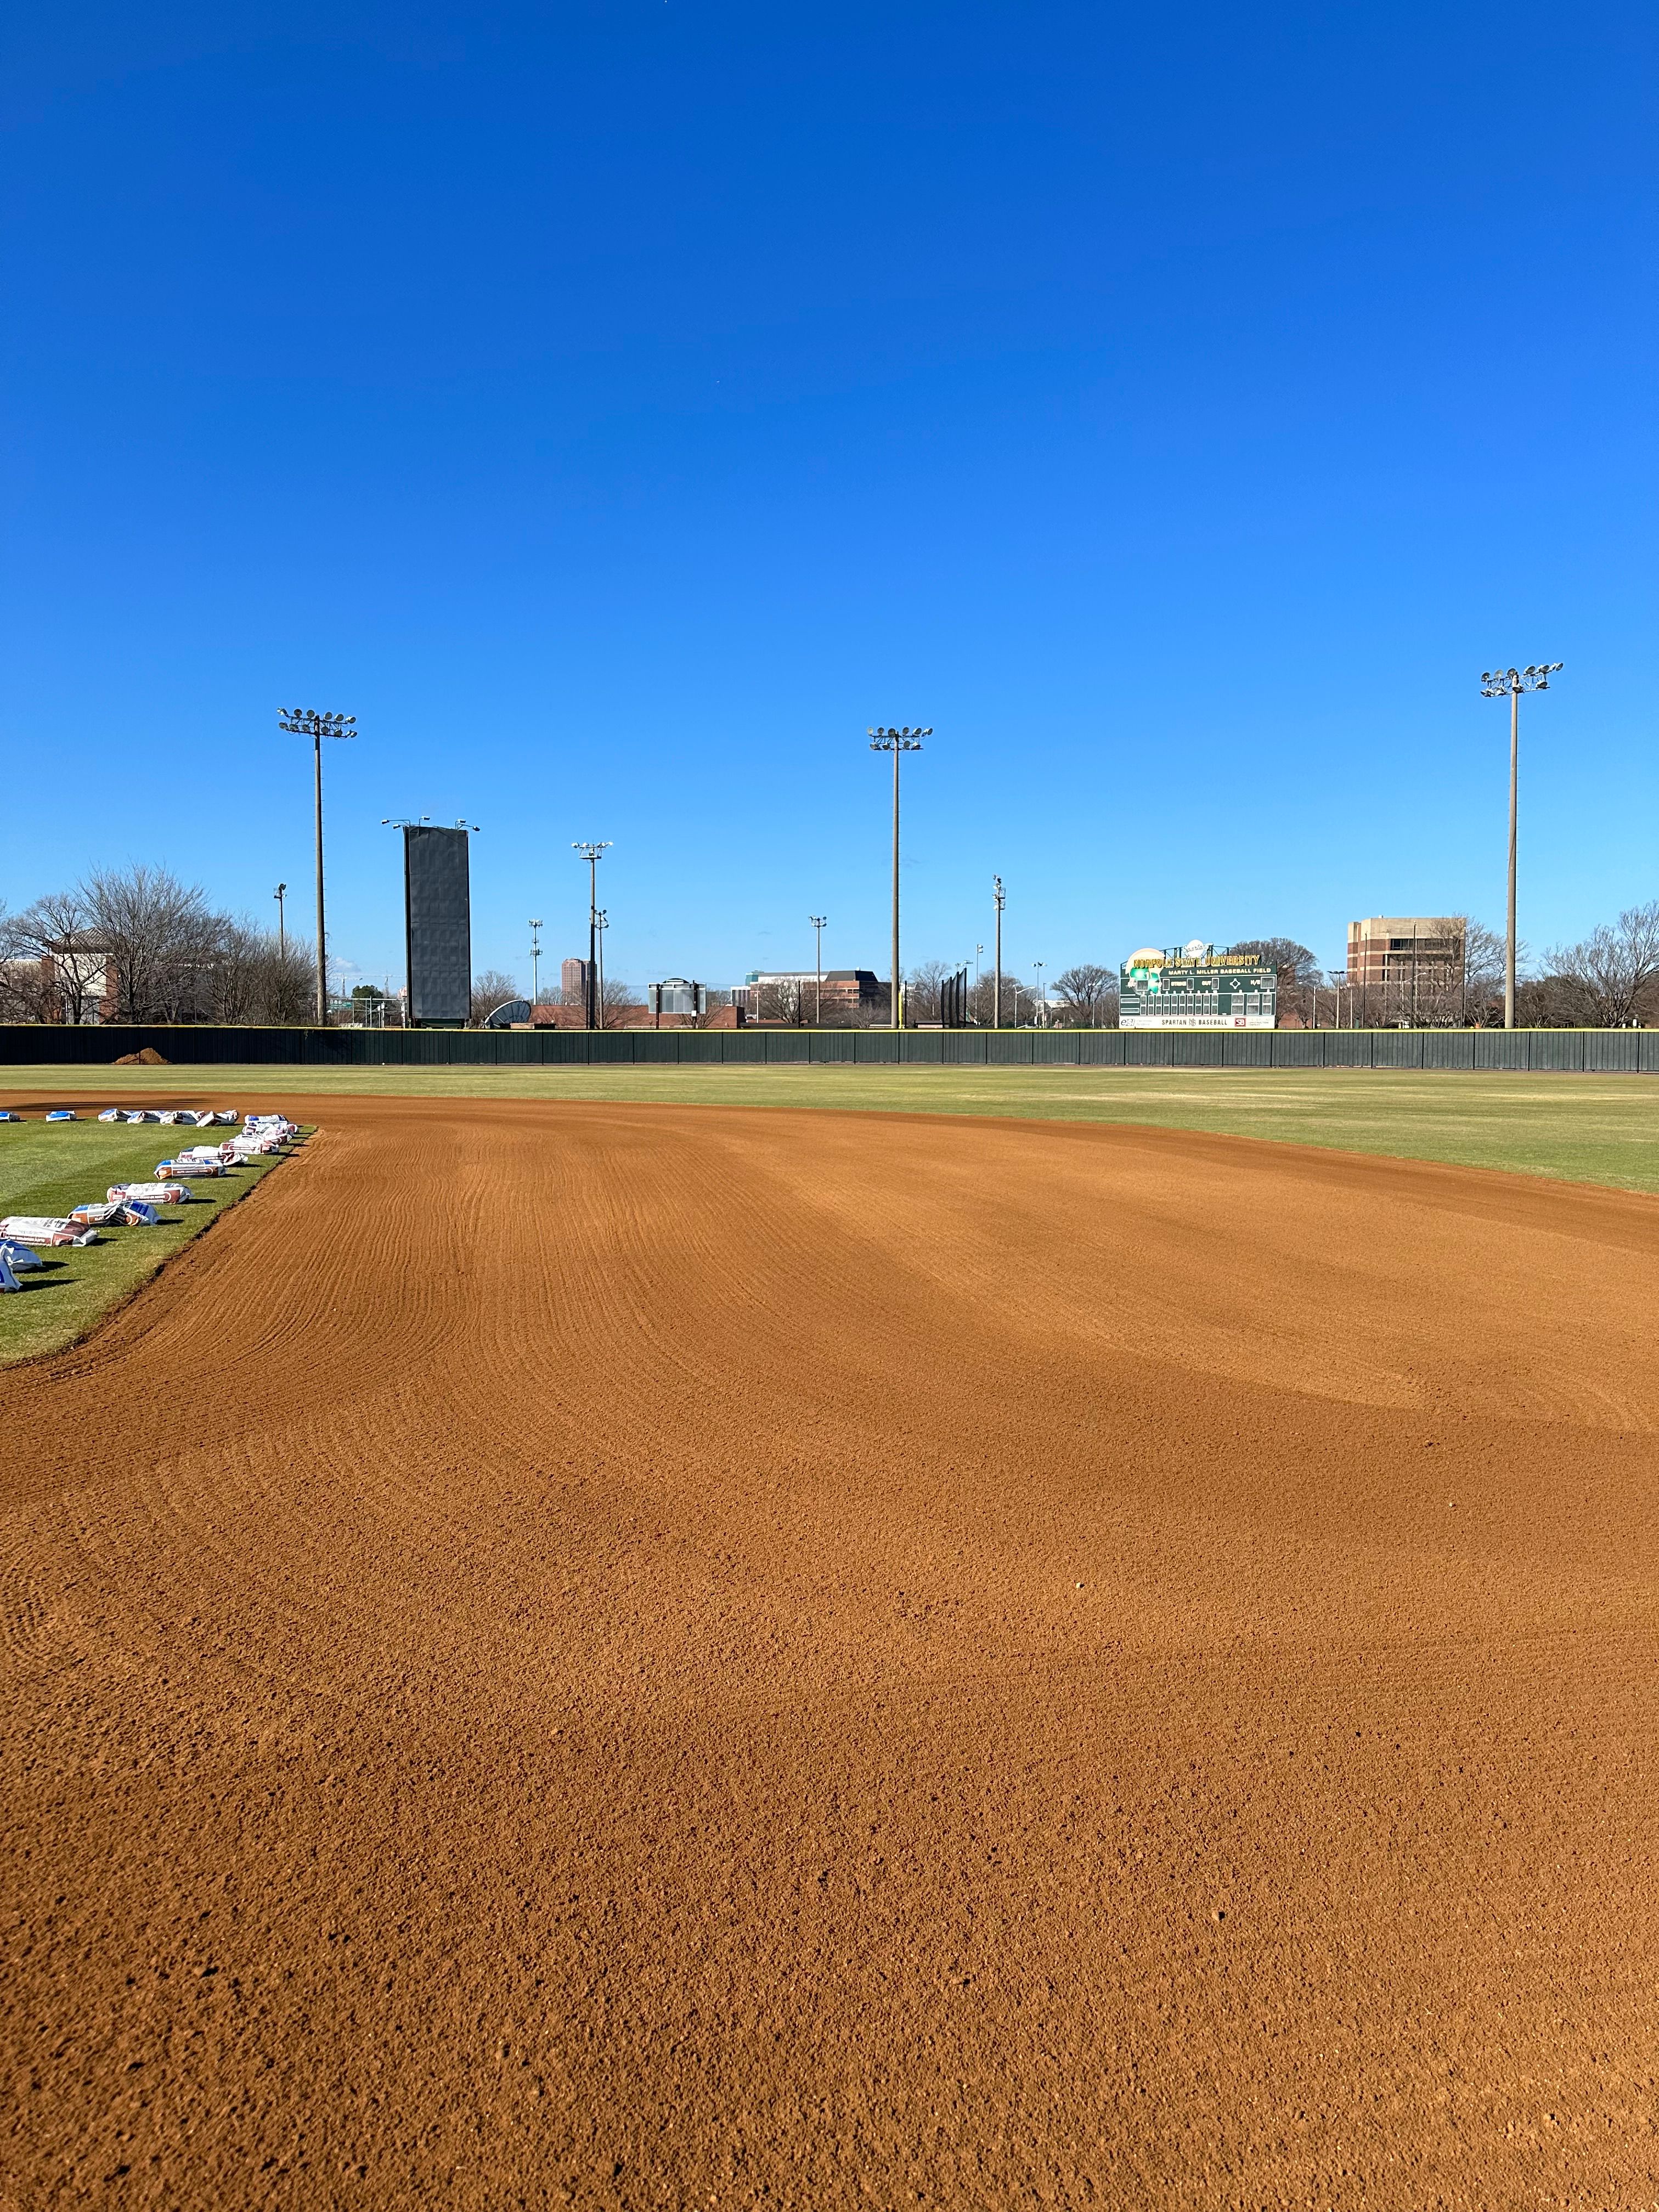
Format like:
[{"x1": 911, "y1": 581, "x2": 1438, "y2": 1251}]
[{"x1": 0, "y1": 1124, "x2": 298, "y2": 1367}]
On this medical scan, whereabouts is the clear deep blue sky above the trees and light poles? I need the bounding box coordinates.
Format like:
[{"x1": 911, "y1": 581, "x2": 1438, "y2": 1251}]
[{"x1": 0, "y1": 0, "x2": 1659, "y2": 982}]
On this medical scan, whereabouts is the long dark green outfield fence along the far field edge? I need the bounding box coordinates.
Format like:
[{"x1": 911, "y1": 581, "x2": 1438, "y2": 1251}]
[{"x1": 0, "y1": 1024, "x2": 1659, "y2": 1075}]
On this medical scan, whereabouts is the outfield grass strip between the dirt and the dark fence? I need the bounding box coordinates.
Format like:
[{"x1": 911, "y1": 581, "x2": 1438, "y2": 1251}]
[{"x1": 0, "y1": 1066, "x2": 1659, "y2": 1192}]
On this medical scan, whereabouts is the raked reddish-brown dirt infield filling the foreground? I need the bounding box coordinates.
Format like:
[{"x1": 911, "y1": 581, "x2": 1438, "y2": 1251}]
[{"x1": 0, "y1": 1097, "x2": 1659, "y2": 2212}]
